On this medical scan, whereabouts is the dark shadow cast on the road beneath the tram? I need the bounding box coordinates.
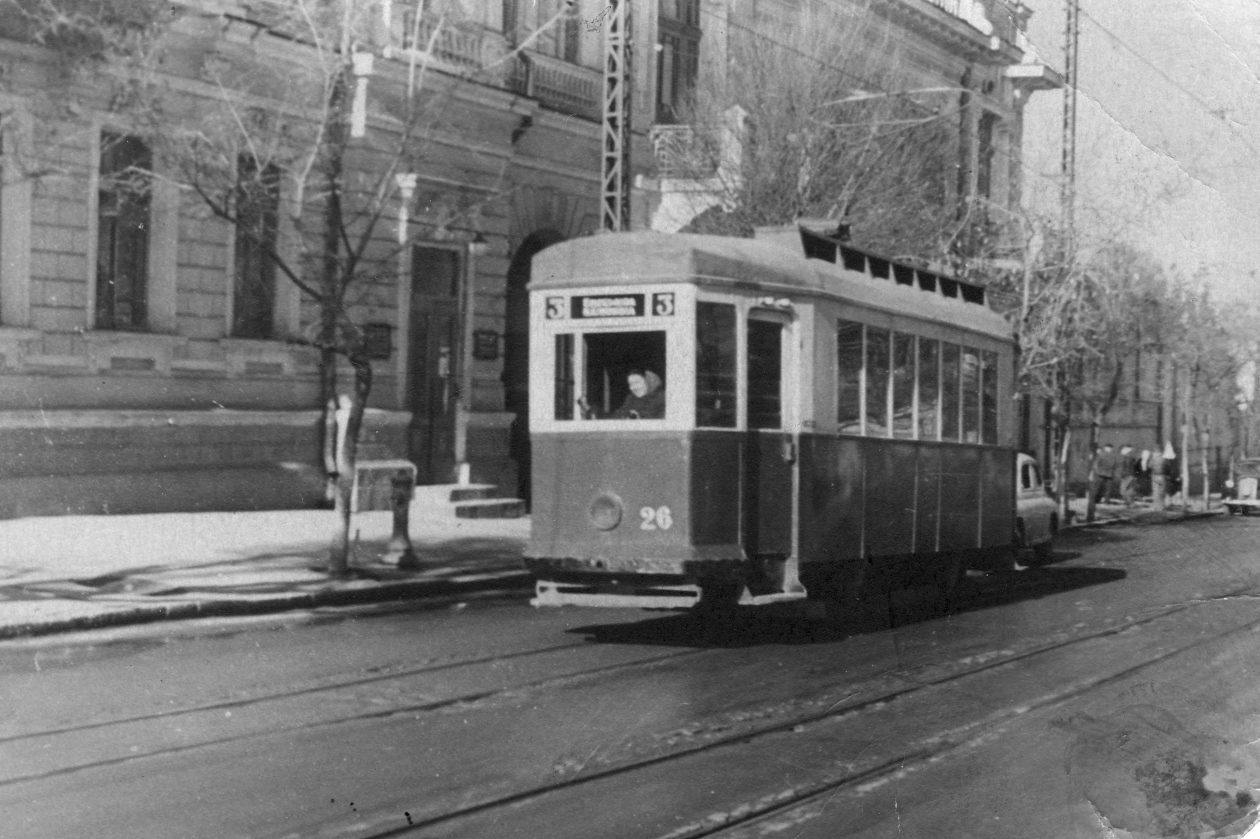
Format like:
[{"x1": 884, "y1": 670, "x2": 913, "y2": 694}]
[{"x1": 568, "y1": 559, "x2": 1126, "y2": 648}]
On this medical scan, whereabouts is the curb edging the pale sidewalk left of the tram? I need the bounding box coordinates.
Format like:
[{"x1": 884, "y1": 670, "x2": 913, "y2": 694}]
[{"x1": 0, "y1": 571, "x2": 534, "y2": 640}]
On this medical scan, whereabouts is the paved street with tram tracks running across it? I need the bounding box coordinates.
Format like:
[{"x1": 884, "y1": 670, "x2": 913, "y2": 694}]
[{"x1": 0, "y1": 518, "x2": 1260, "y2": 839}]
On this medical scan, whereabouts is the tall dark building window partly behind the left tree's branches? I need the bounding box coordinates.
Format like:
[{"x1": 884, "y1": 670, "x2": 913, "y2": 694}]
[{"x1": 232, "y1": 156, "x2": 280, "y2": 339}]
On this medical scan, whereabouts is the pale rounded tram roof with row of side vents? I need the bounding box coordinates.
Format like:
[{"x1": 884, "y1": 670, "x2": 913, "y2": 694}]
[{"x1": 529, "y1": 231, "x2": 1012, "y2": 338}]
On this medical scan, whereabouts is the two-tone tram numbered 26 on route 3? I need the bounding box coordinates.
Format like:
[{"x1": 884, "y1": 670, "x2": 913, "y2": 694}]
[{"x1": 524, "y1": 228, "x2": 1016, "y2": 607}]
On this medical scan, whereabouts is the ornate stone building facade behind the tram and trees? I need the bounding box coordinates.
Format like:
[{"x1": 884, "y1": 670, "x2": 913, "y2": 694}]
[{"x1": 0, "y1": 0, "x2": 1053, "y2": 517}]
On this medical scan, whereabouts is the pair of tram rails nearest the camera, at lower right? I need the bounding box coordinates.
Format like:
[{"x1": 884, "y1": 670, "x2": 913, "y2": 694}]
[{"x1": 299, "y1": 574, "x2": 1260, "y2": 839}]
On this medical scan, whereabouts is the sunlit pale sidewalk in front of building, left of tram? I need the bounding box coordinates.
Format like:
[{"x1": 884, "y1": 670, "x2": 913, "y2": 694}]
[{"x1": 0, "y1": 503, "x2": 532, "y2": 639}]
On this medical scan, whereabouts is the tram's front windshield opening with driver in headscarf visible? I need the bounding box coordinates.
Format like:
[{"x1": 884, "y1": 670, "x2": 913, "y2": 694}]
[{"x1": 577, "y1": 331, "x2": 668, "y2": 420}]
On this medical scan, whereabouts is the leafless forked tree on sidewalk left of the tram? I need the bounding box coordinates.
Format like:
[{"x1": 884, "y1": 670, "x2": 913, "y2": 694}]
[{"x1": 0, "y1": 0, "x2": 521, "y2": 574}]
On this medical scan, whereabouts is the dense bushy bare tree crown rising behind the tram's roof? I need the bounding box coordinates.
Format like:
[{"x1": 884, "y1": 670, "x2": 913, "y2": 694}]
[{"x1": 659, "y1": 1, "x2": 964, "y2": 258}]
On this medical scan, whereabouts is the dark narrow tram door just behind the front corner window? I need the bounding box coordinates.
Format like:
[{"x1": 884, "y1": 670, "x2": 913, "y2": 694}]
[{"x1": 741, "y1": 312, "x2": 796, "y2": 558}]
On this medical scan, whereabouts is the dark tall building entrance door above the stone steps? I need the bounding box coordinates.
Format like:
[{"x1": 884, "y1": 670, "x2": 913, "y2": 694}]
[{"x1": 407, "y1": 246, "x2": 462, "y2": 484}]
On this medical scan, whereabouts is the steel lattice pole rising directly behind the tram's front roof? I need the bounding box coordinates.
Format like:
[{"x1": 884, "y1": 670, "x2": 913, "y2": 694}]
[{"x1": 600, "y1": 0, "x2": 633, "y2": 233}]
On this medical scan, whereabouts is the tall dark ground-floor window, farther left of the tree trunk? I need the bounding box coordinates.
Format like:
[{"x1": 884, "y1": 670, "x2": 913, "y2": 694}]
[{"x1": 96, "y1": 132, "x2": 152, "y2": 330}]
